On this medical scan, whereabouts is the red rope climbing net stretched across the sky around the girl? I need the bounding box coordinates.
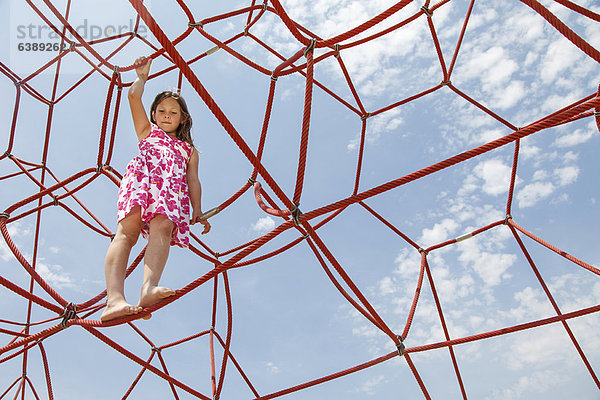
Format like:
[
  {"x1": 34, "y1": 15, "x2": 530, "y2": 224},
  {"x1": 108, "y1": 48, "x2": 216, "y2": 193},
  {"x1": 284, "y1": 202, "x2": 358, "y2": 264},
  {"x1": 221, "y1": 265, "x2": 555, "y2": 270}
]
[{"x1": 0, "y1": 0, "x2": 600, "y2": 399}]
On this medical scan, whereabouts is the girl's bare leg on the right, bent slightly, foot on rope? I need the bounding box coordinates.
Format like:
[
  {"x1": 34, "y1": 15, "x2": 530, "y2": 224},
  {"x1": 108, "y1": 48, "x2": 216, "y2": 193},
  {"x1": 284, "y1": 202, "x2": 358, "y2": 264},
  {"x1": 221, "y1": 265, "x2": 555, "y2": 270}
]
[{"x1": 138, "y1": 214, "x2": 175, "y2": 318}]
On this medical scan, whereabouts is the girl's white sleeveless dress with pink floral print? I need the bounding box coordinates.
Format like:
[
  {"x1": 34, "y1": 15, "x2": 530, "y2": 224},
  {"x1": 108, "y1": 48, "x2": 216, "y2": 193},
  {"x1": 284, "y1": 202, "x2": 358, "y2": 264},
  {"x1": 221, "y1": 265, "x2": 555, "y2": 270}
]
[{"x1": 117, "y1": 124, "x2": 192, "y2": 247}]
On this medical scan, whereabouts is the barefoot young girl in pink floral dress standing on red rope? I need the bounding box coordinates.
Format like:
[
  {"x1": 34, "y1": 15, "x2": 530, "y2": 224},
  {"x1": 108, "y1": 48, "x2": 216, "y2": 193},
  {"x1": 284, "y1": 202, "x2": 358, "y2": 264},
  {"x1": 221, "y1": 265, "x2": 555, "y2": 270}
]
[{"x1": 100, "y1": 57, "x2": 210, "y2": 321}]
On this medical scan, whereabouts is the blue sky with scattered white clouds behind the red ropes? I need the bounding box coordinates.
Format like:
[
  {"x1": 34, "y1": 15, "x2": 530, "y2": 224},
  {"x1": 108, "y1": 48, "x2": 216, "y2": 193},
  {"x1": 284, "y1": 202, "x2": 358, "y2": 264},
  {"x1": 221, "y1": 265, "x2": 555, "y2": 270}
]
[{"x1": 0, "y1": 0, "x2": 600, "y2": 399}]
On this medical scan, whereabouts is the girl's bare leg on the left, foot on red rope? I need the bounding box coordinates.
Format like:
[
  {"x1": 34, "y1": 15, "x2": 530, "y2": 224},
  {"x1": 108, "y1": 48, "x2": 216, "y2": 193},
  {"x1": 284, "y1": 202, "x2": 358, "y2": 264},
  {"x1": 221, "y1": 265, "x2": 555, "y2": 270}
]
[{"x1": 100, "y1": 207, "x2": 142, "y2": 321}]
